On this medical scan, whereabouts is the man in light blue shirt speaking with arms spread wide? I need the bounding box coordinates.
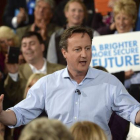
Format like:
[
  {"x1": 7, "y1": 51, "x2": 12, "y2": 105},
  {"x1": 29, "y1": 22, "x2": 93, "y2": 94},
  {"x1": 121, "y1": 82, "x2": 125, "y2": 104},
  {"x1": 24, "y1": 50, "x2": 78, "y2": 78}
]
[{"x1": 0, "y1": 26, "x2": 140, "y2": 140}]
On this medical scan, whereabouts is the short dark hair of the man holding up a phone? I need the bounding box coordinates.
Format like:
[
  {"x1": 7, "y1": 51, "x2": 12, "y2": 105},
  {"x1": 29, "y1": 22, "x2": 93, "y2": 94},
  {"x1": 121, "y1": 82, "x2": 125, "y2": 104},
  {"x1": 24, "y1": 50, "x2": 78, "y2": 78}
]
[{"x1": 21, "y1": 31, "x2": 44, "y2": 44}]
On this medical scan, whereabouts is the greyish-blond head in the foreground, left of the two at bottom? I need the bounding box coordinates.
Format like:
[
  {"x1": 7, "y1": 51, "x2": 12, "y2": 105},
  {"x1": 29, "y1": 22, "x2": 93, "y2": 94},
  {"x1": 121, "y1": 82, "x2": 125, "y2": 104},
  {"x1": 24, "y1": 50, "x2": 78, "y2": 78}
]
[{"x1": 19, "y1": 117, "x2": 74, "y2": 140}]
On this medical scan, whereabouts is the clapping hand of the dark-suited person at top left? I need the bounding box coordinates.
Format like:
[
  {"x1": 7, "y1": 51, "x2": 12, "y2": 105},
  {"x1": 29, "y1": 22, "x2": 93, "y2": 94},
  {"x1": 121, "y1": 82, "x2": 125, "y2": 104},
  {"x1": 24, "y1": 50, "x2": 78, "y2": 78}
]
[{"x1": 17, "y1": 8, "x2": 27, "y2": 25}]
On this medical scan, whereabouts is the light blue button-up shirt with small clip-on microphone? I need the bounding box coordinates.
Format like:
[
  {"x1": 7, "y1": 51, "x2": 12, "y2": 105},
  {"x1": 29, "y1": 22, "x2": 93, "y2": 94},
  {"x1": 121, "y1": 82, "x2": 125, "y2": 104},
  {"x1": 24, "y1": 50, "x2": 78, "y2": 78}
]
[{"x1": 10, "y1": 68, "x2": 140, "y2": 140}]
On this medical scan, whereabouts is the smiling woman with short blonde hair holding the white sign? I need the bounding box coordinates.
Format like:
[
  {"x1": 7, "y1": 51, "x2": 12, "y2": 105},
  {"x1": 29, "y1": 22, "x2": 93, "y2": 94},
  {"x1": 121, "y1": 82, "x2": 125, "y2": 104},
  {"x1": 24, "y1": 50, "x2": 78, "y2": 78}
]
[{"x1": 93, "y1": 0, "x2": 137, "y2": 85}]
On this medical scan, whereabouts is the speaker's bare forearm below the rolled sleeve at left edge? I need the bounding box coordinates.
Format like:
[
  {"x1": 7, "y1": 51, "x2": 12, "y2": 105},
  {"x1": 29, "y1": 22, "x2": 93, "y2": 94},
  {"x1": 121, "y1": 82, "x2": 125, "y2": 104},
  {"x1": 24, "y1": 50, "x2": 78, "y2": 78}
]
[{"x1": 0, "y1": 110, "x2": 17, "y2": 126}]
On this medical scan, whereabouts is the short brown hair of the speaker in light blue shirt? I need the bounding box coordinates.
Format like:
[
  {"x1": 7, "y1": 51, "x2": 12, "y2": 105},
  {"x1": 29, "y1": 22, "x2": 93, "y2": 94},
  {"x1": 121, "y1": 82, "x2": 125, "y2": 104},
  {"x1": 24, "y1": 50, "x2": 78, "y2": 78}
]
[{"x1": 59, "y1": 26, "x2": 93, "y2": 50}]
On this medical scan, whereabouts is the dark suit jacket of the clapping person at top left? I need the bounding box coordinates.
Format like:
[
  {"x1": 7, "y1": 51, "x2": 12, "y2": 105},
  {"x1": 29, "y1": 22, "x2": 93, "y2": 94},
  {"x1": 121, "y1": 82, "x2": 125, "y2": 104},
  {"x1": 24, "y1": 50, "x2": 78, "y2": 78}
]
[{"x1": 3, "y1": 0, "x2": 34, "y2": 28}]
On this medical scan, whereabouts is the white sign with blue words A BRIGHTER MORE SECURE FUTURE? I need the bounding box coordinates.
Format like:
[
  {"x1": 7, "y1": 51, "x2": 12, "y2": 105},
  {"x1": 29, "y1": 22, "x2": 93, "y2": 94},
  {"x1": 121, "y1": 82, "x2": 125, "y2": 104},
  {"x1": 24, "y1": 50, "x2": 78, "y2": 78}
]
[{"x1": 90, "y1": 32, "x2": 140, "y2": 73}]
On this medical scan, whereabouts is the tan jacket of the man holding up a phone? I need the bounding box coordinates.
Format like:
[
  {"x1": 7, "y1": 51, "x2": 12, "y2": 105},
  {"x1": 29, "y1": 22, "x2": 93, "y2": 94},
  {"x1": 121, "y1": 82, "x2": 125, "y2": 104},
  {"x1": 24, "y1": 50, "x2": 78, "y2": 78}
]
[{"x1": 4, "y1": 62, "x2": 65, "y2": 105}]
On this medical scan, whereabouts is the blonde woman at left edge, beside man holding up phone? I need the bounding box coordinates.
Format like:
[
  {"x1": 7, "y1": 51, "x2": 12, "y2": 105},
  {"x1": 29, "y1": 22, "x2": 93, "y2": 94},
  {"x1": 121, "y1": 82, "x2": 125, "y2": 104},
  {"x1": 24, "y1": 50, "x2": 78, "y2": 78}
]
[{"x1": 0, "y1": 26, "x2": 23, "y2": 109}]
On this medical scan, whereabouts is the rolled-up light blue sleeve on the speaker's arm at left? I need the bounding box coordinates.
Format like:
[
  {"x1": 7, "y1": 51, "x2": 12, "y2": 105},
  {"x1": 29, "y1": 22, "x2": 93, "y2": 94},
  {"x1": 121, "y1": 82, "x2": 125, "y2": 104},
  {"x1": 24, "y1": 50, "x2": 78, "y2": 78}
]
[{"x1": 9, "y1": 77, "x2": 45, "y2": 128}]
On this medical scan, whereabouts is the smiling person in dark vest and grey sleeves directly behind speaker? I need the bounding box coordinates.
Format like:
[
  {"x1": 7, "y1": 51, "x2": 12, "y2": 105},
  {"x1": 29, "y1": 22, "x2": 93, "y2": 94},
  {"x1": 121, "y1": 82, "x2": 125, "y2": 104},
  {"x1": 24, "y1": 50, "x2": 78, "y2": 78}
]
[{"x1": 47, "y1": 0, "x2": 99, "y2": 65}]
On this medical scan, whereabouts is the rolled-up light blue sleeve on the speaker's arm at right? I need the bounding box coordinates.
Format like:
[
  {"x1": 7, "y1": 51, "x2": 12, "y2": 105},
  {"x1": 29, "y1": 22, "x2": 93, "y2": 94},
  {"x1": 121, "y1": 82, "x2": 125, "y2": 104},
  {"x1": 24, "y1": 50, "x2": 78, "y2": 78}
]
[{"x1": 111, "y1": 76, "x2": 140, "y2": 124}]
